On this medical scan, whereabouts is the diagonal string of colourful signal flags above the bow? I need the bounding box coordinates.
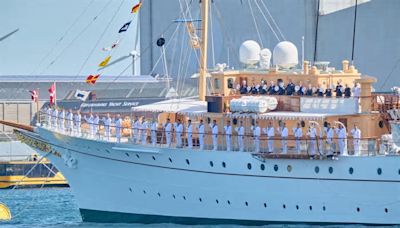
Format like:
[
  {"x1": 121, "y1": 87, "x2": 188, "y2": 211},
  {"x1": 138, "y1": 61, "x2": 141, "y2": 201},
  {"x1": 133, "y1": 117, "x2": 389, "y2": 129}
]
[{"x1": 86, "y1": 0, "x2": 143, "y2": 85}]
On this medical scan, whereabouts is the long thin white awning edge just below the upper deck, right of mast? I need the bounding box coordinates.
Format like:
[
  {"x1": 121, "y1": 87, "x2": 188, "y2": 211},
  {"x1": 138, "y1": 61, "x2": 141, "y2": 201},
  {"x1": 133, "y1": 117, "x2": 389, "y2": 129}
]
[{"x1": 228, "y1": 112, "x2": 335, "y2": 121}]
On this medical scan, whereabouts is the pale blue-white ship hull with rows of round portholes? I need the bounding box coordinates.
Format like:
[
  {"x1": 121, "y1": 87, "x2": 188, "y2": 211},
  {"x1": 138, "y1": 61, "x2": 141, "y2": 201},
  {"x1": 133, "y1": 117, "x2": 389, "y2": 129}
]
[{"x1": 21, "y1": 129, "x2": 400, "y2": 225}]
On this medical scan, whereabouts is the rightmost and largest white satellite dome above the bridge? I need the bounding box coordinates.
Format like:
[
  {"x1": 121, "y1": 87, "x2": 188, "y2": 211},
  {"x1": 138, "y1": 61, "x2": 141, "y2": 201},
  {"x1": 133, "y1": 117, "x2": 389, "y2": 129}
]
[{"x1": 273, "y1": 41, "x2": 299, "y2": 68}]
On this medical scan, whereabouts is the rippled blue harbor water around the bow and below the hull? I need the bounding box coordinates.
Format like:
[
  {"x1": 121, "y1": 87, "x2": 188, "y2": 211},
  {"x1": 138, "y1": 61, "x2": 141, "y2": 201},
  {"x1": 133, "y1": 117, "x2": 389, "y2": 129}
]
[{"x1": 0, "y1": 188, "x2": 394, "y2": 228}]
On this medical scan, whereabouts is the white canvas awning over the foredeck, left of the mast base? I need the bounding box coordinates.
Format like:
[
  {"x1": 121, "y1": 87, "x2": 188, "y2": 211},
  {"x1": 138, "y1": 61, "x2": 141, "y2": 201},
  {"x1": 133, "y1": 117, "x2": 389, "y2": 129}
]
[{"x1": 132, "y1": 98, "x2": 207, "y2": 116}]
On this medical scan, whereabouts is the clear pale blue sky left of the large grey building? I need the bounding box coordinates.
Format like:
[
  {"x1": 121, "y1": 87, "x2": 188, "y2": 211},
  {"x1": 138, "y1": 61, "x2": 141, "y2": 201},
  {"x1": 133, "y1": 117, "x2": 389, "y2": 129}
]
[{"x1": 0, "y1": 0, "x2": 140, "y2": 75}]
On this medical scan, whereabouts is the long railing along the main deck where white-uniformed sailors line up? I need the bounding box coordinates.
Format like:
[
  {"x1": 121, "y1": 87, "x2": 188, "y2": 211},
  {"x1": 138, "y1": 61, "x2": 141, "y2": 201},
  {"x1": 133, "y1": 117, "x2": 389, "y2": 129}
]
[{"x1": 35, "y1": 113, "x2": 391, "y2": 156}]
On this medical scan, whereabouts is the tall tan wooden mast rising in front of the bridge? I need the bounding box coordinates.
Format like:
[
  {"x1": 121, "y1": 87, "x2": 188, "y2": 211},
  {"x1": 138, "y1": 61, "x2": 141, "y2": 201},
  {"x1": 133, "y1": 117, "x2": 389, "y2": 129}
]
[{"x1": 199, "y1": 0, "x2": 209, "y2": 101}]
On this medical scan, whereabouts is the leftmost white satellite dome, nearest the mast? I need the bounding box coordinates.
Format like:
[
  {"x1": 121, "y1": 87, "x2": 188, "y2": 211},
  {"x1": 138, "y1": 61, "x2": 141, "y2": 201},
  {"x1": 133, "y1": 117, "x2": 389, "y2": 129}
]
[{"x1": 239, "y1": 40, "x2": 261, "y2": 65}]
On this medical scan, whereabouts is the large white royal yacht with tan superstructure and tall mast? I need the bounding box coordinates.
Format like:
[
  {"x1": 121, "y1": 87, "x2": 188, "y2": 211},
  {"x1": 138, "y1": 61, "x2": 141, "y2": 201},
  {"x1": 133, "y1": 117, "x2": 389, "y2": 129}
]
[{"x1": 5, "y1": 0, "x2": 400, "y2": 225}]
